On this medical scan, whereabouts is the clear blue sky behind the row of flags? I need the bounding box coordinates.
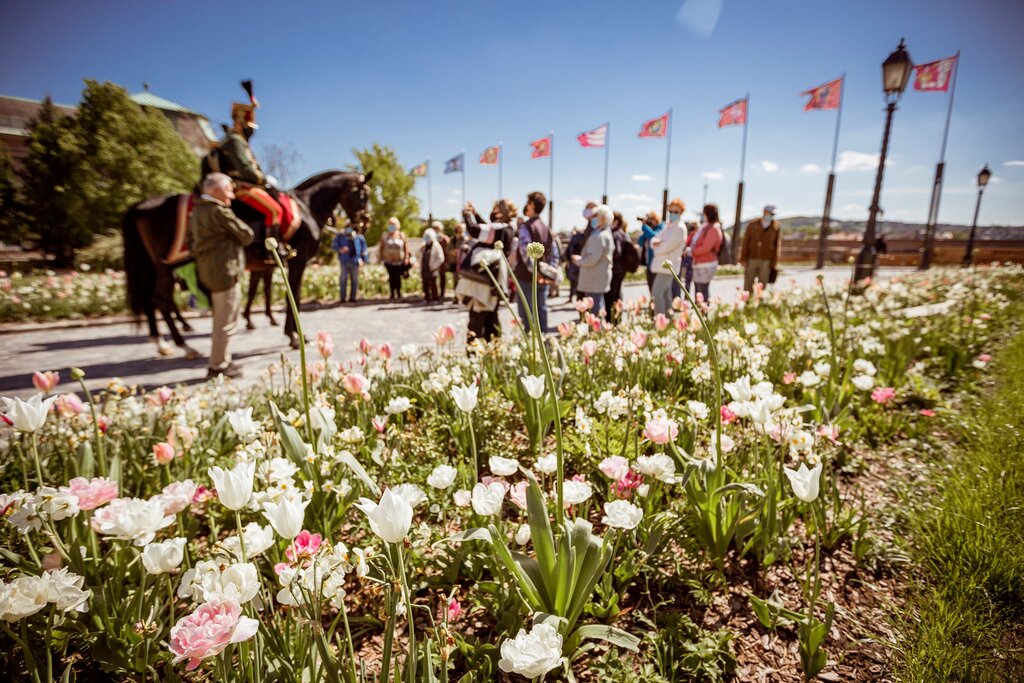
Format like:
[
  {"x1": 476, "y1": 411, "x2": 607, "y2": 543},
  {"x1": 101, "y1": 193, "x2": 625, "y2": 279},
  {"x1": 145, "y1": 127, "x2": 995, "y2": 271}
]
[{"x1": 0, "y1": 0, "x2": 1024, "y2": 232}]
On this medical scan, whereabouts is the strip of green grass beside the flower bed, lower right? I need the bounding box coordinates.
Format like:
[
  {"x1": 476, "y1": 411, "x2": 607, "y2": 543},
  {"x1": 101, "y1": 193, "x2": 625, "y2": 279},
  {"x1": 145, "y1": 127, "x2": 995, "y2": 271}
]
[{"x1": 895, "y1": 325, "x2": 1024, "y2": 683}]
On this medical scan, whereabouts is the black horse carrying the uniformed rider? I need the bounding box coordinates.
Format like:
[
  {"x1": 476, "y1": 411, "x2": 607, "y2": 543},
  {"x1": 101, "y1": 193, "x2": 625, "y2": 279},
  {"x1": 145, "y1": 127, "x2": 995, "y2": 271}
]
[{"x1": 121, "y1": 171, "x2": 373, "y2": 359}]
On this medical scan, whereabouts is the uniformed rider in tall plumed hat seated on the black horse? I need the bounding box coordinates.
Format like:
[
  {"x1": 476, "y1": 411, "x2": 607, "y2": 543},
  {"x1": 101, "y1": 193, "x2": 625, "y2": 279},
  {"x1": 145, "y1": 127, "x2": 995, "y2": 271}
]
[{"x1": 204, "y1": 81, "x2": 295, "y2": 259}]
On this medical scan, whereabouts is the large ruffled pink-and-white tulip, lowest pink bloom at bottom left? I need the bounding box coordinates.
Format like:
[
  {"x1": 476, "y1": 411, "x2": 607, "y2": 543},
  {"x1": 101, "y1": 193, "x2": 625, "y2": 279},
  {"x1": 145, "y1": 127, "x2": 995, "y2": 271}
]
[{"x1": 170, "y1": 600, "x2": 259, "y2": 671}]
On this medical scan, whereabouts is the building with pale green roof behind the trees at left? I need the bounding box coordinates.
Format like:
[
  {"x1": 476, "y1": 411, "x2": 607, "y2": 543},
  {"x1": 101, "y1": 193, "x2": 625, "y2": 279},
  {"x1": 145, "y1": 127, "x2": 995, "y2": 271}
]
[{"x1": 0, "y1": 86, "x2": 217, "y2": 167}]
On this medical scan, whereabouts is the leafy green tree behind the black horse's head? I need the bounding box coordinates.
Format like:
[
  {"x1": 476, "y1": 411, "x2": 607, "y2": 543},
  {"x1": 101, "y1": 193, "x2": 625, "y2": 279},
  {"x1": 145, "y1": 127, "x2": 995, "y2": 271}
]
[{"x1": 350, "y1": 142, "x2": 423, "y2": 245}]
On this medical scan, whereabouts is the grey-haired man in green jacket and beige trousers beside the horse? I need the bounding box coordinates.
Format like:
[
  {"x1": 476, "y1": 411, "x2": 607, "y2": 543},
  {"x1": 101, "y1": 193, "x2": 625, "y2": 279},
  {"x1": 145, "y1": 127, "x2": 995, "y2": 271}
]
[{"x1": 188, "y1": 173, "x2": 255, "y2": 379}]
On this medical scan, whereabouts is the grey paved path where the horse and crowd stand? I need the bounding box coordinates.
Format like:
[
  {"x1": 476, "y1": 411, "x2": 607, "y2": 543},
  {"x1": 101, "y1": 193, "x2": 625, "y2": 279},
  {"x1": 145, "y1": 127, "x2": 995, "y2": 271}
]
[{"x1": 0, "y1": 268, "x2": 905, "y2": 397}]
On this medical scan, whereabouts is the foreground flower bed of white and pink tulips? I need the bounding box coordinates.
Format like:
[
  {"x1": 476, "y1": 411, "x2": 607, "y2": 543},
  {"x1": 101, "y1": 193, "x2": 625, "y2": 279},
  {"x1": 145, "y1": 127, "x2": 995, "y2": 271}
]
[{"x1": 0, "y1": 267, "x2": 1024, "y2": 681}]
